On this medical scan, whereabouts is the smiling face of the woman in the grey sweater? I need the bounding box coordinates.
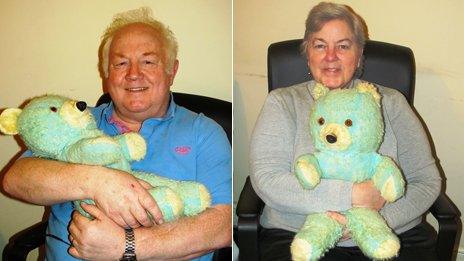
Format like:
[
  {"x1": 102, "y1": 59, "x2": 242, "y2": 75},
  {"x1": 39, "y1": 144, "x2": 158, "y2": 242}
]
[{"x1": 306, "y1": 19, "x2": 362, "y2": 89}]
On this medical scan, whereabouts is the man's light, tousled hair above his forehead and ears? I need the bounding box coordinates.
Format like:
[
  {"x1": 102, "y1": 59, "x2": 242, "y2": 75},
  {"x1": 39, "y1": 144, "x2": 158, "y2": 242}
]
[{"x1": 99, "y1": 7, "x2": 178, "y2": 78}]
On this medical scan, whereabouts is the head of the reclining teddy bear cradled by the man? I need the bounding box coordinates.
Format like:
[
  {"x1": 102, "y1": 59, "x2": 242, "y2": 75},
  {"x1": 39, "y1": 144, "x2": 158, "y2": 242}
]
[{"x1": 0, "y1": 95, "x2": 97, "y2": 158}]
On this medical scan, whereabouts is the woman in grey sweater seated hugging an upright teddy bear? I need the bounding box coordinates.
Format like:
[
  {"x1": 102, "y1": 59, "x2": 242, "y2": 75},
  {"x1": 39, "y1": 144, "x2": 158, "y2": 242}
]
[{"x1": 250, "y1": 3, "x2": 441, "y2": 260}]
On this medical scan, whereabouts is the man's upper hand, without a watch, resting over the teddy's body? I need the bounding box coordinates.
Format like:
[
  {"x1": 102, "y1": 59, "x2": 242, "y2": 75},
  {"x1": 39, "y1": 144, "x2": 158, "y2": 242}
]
[{"x1": 89, "y1": 168, "x2": 163, "y2": 228}]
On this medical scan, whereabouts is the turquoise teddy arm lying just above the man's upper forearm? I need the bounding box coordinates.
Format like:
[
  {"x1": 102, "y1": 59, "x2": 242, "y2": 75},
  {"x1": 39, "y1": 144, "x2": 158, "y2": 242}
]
[{"x1": 64, "y1": 136, "x2": 121, "y2": 166}]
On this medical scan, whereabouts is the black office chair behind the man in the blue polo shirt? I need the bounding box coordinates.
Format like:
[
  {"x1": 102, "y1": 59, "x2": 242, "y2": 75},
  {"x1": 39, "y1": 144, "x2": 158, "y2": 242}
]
[{"x1": 2, "y1": 92, "x2": 232, "y2": 261}]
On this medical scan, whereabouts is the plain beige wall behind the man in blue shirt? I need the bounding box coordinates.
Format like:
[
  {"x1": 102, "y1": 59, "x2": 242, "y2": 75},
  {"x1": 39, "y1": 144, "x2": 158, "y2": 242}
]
[{"x1": 0, "y1": 0, "x2": 232, "y2": 256}]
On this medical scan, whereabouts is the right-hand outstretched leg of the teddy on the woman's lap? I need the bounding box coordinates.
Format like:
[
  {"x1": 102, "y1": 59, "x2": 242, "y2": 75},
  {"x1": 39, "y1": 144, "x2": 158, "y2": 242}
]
[{"x1": 345, "y1": 208, "x2": 400, "y2": 259}]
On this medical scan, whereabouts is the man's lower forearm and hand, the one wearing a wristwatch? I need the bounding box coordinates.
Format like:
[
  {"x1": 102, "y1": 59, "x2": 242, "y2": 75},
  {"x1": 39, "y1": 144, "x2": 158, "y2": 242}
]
[{"x1": 69, "y1": 204, "x2": 232, "y2": 260}]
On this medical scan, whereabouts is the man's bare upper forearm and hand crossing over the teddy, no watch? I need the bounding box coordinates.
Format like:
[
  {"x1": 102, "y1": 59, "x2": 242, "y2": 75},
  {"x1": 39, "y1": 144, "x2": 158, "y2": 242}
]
[{"x1": 3, "y1": 155, "x2": 162, "y2": 227}]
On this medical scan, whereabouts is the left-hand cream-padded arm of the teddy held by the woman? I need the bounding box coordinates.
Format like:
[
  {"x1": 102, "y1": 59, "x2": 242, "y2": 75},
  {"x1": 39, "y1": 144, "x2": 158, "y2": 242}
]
[{"x1": 295, "y1": 154, "x2": 321, "y2": 189}]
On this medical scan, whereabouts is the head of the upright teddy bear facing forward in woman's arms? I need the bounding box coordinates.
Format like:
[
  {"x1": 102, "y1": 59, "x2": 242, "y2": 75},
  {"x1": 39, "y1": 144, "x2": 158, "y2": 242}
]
[{"x1": 309, "y1": 82, "x2": 384, "y2": 153}]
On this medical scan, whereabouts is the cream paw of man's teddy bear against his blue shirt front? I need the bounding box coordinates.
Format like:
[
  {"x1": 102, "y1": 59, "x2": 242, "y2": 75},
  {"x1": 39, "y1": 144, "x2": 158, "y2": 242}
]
[{"x1": 113, "y1": 132, "x2": 147, "y2": 161}]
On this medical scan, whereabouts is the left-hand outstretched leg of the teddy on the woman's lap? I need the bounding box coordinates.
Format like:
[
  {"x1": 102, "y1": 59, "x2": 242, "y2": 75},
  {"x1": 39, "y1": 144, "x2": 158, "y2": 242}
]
[{"x1": 290, "y1": 213, "x2": 343, "y2": 261}]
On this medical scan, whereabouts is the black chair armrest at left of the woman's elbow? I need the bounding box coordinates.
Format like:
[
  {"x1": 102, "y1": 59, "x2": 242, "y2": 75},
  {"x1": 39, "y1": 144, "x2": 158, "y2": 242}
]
[{"x1": 235, "y1": 177, "x2": 264, "y2": 261}]
